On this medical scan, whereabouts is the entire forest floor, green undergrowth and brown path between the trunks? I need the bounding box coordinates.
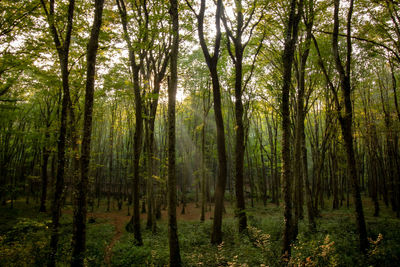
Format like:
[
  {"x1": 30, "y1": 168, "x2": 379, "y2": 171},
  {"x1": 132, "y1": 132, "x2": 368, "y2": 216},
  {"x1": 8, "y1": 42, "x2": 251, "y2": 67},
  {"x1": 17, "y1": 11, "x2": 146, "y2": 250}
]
[{"x1": 0, "y1": 198, "x2": 400, "y2": 267}]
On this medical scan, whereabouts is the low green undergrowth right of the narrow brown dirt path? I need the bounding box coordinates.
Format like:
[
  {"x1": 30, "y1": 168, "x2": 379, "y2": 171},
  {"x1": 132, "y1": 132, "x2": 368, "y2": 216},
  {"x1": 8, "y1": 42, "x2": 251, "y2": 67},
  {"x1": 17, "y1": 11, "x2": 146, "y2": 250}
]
[{"x1": 112, "y1": 201, "x2": 400, "y2": 266}]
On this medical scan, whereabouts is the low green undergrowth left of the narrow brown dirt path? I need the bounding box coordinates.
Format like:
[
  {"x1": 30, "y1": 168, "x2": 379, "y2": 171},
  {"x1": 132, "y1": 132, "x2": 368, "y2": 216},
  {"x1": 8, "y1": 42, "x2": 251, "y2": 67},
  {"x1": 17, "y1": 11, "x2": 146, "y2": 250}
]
[{"x1": 0, "y1": 201, "x2": 114, "y2": 267}]
